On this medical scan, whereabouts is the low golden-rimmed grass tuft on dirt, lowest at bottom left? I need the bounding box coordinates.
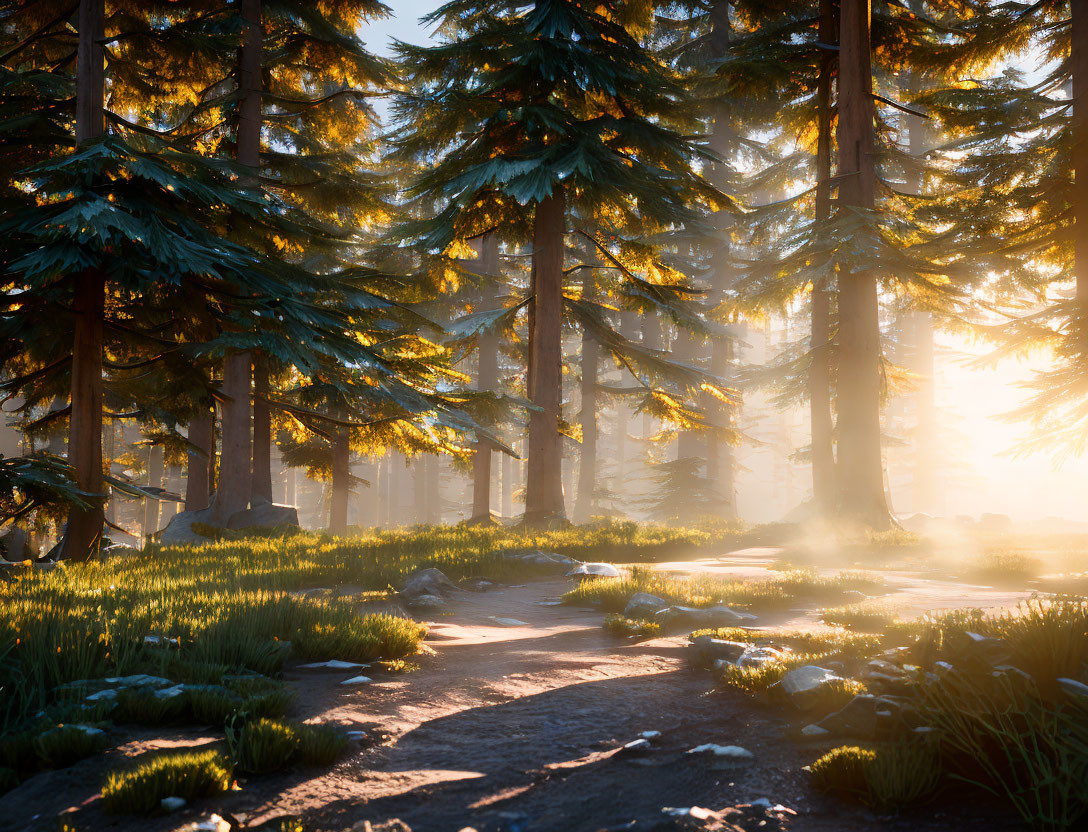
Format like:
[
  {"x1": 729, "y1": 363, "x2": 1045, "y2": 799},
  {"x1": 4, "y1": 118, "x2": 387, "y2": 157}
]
[{"x1": 102, "y1": 749, "x2": 231, "y2": 815}]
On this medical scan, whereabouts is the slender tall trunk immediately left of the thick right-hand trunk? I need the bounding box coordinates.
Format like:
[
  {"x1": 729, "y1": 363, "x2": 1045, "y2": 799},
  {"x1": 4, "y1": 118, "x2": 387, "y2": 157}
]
[{"x1": 808, "y1": 0, "x2": 836, "y2": 514}]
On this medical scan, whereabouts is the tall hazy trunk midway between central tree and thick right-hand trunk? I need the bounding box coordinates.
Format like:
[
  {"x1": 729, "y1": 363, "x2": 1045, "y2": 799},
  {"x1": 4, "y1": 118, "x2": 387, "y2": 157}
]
[{"x1": 704, "y1": 0, "x2": 737, "y2": 519}]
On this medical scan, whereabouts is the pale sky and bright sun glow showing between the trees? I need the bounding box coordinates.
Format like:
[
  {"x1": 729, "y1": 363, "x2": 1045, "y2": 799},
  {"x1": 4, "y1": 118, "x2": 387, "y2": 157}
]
[{"x1": 360, "y1": 0, "x2": 1088, "y2": 522}]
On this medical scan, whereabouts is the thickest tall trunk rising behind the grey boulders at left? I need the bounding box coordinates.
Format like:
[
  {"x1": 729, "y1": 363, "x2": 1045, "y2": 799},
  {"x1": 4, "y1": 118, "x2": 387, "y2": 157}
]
[{"x1": 214, "y1": 0, "x2": 264, "y2": 524}]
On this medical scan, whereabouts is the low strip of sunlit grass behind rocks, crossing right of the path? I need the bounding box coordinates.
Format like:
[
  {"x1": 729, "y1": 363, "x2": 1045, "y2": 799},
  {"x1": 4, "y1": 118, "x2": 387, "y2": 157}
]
[{"x1": 562, "y1": 567, "x2": 883, "y2": 612}]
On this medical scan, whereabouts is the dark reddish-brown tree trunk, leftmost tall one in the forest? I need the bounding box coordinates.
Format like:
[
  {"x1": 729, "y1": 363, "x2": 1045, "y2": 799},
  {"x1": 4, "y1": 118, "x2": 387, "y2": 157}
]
[{"x1": 60, "y1": 0, "x2": 106, "y2": 560}]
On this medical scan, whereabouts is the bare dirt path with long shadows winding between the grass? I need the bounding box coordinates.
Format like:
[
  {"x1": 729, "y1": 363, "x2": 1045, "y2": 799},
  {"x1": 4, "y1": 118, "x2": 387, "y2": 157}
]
[{"x1": 0, "y1": 549, "x2": 1024, "y2": 832}]
